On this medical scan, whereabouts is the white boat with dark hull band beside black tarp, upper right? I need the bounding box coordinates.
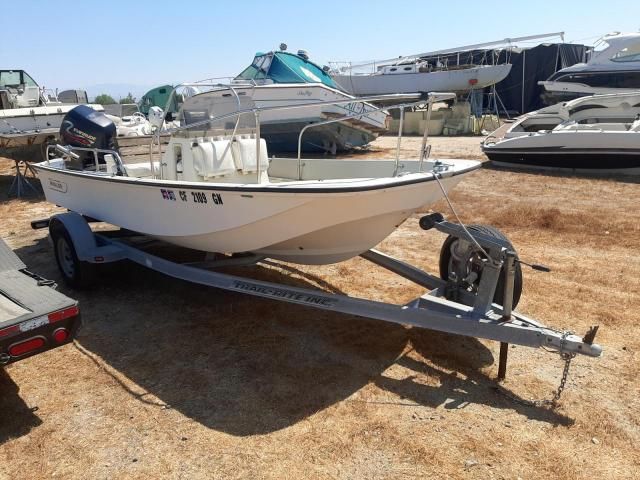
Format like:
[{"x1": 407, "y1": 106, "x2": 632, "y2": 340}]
[{"x1": 538, "y1": 33, "x2": 640, "y2": 103}]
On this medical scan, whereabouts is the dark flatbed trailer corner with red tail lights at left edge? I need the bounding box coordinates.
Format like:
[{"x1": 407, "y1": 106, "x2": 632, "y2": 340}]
[{"x1": 0, "y1": 239, "x2": 80, "y2": 368}]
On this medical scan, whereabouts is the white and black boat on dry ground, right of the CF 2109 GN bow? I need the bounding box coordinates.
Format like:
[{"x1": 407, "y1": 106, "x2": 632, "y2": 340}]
[{"x1": 482, "y1": 92, "x2": 640, "y2": 175}]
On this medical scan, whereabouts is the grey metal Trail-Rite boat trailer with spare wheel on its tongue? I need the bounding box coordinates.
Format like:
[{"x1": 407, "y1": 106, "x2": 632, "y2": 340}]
[{"x1": 31, "y1": 212, "x2": 602, "y2": 400}]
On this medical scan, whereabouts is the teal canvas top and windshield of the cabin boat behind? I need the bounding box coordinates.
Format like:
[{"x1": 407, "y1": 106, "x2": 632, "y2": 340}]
[{"x1": 235, "y1": 52, "x2": 338, "y2": 88}]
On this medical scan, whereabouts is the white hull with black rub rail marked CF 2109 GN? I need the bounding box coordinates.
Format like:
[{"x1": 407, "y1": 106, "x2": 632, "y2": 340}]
[{"x1": 35, "y1": 160, "x2": 479, "y2": 264}]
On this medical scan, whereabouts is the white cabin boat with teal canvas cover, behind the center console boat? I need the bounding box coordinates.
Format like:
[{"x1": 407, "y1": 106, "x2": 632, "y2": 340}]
[{"x1": 189, "y1": 44, "x2": 388, "y2": 154}]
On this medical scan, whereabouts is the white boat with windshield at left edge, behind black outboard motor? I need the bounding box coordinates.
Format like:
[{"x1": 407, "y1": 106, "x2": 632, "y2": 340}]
[{"x1": 0, "y1": 70, "x2": 102, "y2": 135}]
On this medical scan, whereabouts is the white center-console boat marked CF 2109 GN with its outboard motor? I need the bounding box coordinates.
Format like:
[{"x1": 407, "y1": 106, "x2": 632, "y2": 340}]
[{"x1": 34, "y1": 92, "x2": 480, "y2": 264}]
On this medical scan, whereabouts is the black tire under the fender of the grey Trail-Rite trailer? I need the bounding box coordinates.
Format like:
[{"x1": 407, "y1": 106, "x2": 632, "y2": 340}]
[{"x1": 49, "y1": 223, "x2": 96, "y2": 289}]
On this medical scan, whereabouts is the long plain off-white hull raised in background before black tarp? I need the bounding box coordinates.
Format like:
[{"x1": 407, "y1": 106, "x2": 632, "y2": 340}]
[{"x1": 333, "y1": 64, "x2": 511, "y2": 96}]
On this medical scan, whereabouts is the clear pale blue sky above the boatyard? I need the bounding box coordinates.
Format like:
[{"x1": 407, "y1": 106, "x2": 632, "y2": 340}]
[{"x1": 0, "y1": 0, "x2": 640, "y2": 98}]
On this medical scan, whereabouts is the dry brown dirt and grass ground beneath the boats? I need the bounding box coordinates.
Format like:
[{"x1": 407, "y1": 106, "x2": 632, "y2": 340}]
[{"x1": 0, "y1": 137, "x2": 640, "y2": 480}]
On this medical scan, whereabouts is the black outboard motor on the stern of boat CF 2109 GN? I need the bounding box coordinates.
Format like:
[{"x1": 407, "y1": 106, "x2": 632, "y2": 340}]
[{"x1": 60, "y1": 105, "x2": 118, "y2": 168}]
